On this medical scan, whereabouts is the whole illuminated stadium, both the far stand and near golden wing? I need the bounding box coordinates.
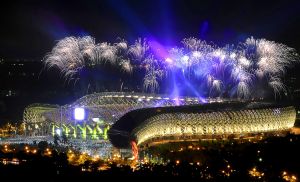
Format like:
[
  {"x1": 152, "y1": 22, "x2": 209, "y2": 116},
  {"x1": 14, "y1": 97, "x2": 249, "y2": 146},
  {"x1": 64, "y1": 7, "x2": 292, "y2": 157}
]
[{"x1": 24, "y1": 92, "x2": 296, "y2": 151}]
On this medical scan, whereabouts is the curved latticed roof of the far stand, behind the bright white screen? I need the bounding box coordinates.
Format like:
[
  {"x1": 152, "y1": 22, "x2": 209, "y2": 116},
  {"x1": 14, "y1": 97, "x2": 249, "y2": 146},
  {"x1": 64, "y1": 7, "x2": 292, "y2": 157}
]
[{"x1": 27, "y1": 92, "x2": 204, "y2": 124}]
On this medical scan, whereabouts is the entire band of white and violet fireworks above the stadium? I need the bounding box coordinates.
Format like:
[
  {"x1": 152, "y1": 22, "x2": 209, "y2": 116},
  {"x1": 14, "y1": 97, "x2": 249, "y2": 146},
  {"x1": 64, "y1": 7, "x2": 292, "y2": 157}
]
[{"x1": 44, "y1": 36, "x2": 299, "y2": 99}]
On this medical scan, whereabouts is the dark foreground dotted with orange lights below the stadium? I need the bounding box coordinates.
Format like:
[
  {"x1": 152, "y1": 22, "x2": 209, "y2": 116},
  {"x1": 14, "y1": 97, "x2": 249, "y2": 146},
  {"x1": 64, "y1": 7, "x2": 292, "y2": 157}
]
[{"x1": 0, "y1": 135, "x2": 300, "y2": 181}]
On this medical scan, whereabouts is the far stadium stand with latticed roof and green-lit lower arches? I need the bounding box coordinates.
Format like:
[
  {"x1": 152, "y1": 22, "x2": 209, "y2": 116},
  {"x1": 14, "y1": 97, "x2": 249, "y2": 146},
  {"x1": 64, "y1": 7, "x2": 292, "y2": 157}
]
[{"x1": 23, "y1": 92, "x2": 206, "y2": 140}]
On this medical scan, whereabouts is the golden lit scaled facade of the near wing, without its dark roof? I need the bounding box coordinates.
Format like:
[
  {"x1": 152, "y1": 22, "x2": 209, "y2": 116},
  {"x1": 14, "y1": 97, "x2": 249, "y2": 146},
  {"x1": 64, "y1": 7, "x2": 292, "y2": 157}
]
[{"x1": 133, "y1": 107, "x2": 296, "y2": 146}]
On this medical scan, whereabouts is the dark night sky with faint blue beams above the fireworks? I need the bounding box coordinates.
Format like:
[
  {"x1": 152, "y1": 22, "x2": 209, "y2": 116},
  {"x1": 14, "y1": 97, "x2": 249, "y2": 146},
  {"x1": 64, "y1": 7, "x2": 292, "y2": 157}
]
[{"x1": 0, "y1": 0, "x2": 300, "y2": 60}]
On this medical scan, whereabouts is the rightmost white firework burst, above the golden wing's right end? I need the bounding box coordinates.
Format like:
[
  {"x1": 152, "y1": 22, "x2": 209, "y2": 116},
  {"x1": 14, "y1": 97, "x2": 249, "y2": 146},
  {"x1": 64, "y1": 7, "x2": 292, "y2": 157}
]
[{"x1": 243, "y1": 37, "x2": 299, "y2": 96}]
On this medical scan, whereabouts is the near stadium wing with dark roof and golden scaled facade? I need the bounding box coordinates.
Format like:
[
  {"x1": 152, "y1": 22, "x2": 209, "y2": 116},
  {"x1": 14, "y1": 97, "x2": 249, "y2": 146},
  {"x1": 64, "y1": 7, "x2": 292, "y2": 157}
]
[{"x1": 110, "y1": 101, "x2": 296, "y2": 147}]
